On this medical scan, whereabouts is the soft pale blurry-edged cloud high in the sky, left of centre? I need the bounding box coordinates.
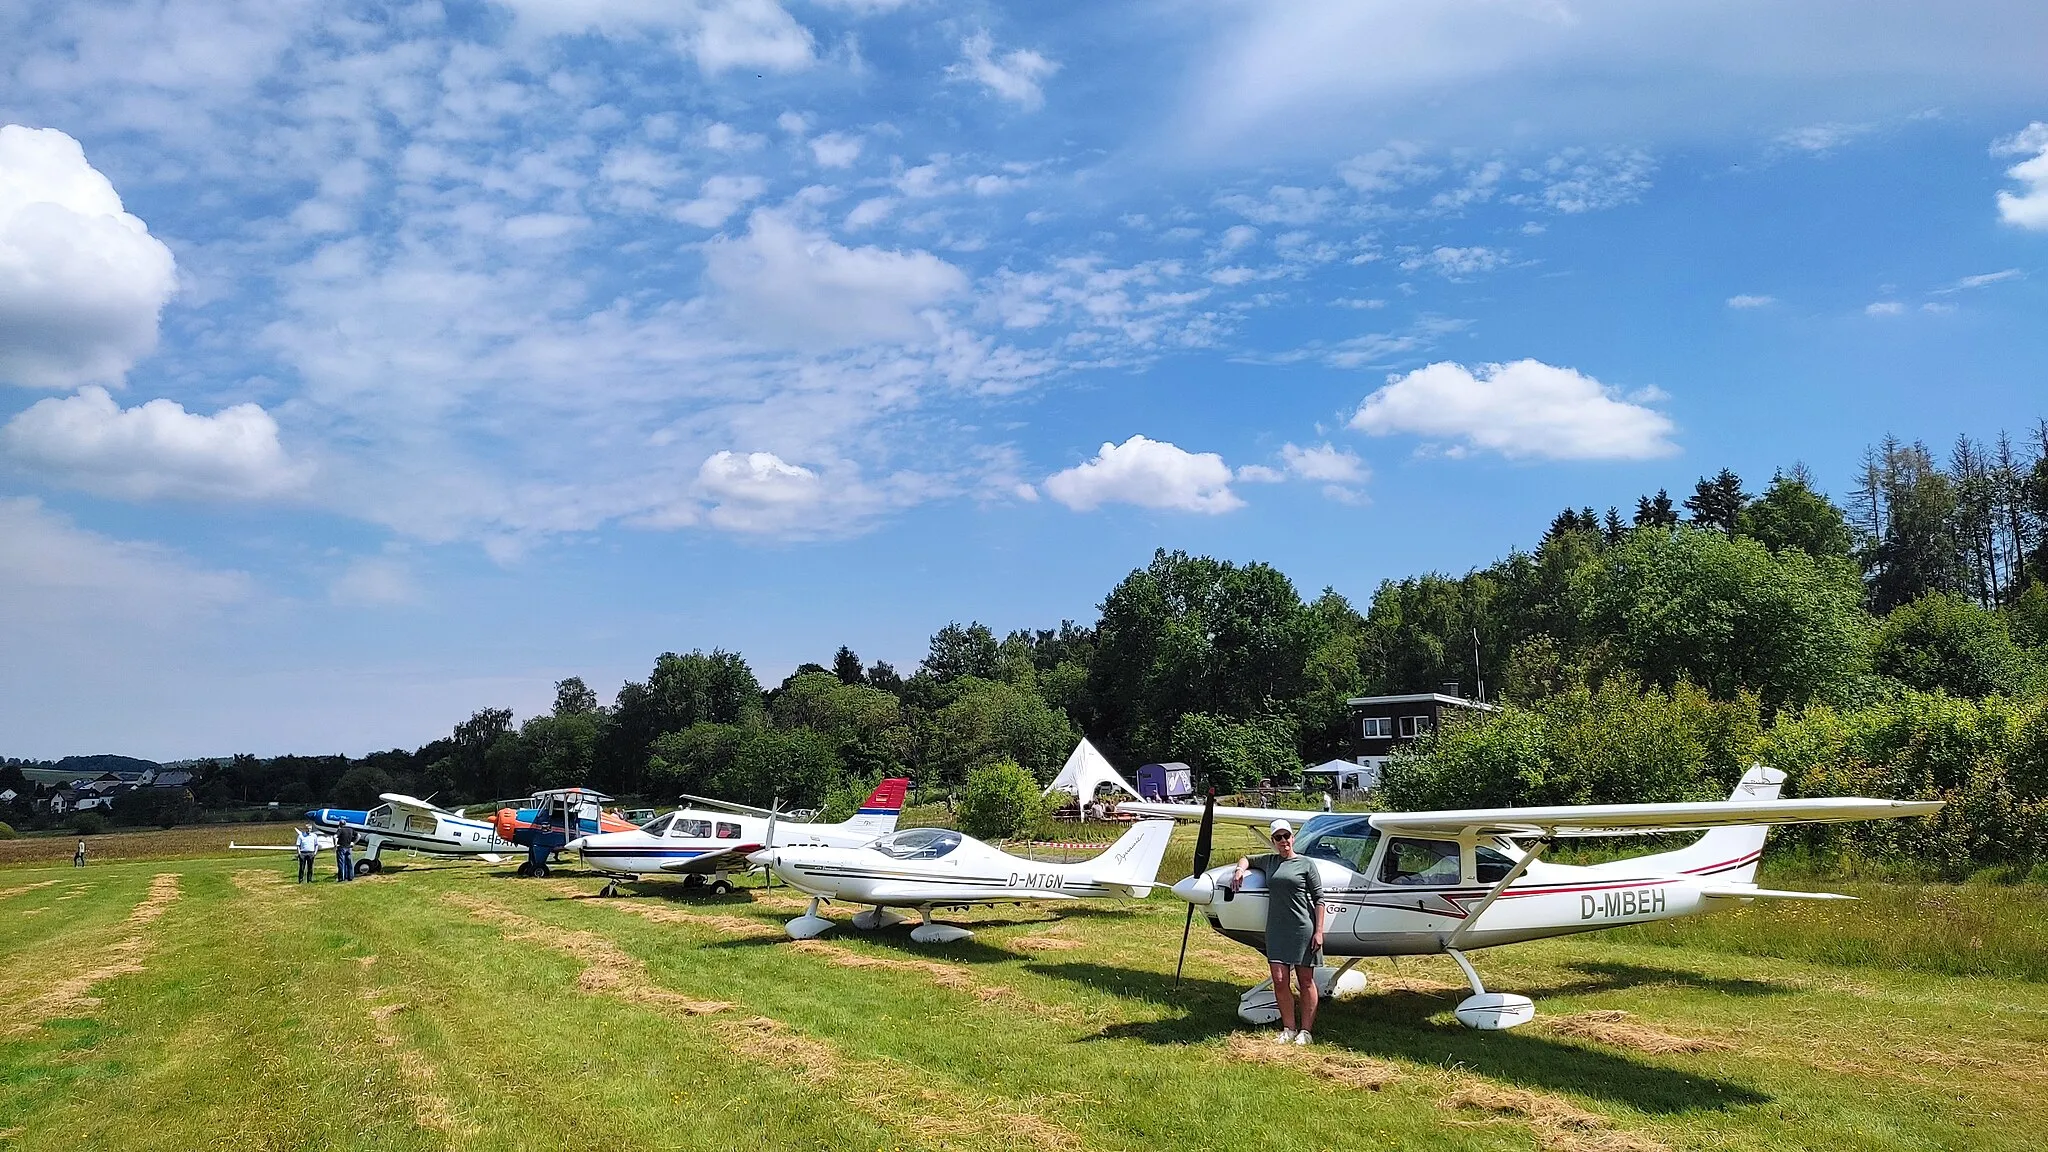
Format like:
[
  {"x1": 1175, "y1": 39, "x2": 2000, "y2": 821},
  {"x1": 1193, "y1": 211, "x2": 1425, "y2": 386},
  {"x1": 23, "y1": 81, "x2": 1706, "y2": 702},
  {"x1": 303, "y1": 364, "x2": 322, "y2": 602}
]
[{"x1": 705, "y1": 209, "x2": 967, "y2": 348}]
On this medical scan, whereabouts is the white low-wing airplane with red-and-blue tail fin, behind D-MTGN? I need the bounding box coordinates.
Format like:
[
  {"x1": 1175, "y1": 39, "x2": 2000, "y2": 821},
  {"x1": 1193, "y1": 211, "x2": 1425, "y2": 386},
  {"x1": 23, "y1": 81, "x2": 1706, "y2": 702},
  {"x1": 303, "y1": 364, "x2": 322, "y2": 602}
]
[{"x1": 567, "y1": 777, "x2": 909, "y2": 896}]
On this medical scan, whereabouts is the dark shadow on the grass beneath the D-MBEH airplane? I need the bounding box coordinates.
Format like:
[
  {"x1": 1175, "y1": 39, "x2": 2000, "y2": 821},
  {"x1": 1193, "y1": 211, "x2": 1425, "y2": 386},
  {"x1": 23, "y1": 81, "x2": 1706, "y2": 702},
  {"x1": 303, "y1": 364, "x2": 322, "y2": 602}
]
[{"x1": 1026, "y1": 963, "x2": 1769, "y2": 1115}]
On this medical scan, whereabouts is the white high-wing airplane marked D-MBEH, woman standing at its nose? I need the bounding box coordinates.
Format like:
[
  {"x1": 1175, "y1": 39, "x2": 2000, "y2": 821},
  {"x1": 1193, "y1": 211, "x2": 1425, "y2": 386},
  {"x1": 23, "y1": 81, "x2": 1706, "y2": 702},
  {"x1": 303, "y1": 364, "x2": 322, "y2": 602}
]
[{"x1": 1118, "y1": 765, "x2": 1942, "y2": 1029}]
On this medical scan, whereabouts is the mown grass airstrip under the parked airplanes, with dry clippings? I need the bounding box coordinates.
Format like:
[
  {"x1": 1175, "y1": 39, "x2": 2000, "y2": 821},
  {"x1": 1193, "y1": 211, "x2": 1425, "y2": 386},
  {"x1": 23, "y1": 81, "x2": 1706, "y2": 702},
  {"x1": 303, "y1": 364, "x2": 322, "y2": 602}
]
[{"x1": 0, "y1": 834, "x2": 2048, "y2": 1152}]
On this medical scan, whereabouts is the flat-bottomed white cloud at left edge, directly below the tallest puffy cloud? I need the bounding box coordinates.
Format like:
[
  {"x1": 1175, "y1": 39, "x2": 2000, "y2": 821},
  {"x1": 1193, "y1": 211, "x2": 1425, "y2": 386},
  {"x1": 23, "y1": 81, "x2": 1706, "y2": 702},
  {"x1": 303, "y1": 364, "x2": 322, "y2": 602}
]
[{"x1": 0, "y1": 385, "x2": 311, "y2": 500}]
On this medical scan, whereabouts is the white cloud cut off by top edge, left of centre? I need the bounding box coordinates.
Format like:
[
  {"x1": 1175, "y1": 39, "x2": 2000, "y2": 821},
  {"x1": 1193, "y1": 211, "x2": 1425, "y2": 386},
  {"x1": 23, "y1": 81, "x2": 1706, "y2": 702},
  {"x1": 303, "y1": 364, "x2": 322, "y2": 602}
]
[{"x1": 502, "y1": 0, "x2": 813, "y2": 74}]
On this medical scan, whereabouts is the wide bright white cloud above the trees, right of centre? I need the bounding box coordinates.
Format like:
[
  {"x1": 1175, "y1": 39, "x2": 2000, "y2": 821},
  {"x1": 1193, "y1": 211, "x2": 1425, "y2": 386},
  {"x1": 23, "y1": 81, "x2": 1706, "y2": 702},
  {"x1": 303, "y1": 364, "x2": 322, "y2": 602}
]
[{"x1": 1350, "y1": 361, "x2": 1677, "y2": 459}]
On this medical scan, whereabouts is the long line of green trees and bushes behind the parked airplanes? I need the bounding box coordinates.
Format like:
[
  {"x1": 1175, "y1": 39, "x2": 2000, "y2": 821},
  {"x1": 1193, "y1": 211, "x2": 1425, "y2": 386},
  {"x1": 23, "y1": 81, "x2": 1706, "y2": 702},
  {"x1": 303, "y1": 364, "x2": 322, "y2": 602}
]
[{"x1": 4, "y1": 422, "x2": 2048, "y2": 861}]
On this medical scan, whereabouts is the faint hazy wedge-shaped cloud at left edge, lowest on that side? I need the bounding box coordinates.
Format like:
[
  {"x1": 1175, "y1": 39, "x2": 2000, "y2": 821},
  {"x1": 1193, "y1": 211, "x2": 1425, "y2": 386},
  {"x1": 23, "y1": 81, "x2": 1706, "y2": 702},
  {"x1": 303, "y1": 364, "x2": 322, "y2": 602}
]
[{"x1": 0, "y1": 496, "x2": 250, "y2": 633}]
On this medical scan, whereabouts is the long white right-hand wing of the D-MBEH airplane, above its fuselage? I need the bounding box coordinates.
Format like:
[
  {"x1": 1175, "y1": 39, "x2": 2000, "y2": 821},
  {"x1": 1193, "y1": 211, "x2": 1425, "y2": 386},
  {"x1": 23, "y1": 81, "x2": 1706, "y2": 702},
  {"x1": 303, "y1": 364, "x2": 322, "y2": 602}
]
[{"x1": 1376, "y1": 795, "x2": 1942, "y2": 836}]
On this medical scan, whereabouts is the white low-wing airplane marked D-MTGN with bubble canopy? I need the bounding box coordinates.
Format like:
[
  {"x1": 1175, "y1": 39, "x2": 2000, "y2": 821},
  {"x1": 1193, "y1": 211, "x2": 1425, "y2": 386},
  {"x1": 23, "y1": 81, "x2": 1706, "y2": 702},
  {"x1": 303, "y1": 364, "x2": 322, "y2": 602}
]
[{"x1": 748, "y1": 820, "x2": 1174, "y2": 943}]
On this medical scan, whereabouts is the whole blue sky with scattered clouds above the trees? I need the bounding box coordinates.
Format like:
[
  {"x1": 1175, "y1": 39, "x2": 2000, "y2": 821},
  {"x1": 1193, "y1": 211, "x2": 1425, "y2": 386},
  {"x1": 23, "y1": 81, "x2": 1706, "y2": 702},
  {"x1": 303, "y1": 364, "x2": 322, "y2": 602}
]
[{"x1": 0, "y1": 0, "x2": 2048, "y2": 758}]
